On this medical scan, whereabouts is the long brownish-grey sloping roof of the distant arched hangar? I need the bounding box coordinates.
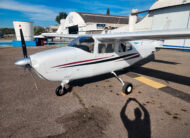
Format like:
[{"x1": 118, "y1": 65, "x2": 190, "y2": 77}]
[{"x1": 77, "y1": 12, "x2": 129, "y2": 24}]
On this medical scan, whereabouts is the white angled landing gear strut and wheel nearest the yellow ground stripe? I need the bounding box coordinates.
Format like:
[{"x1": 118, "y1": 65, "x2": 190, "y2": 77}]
[{"x1": 111, "y1": 71, "x2": 133, "y2": 95}]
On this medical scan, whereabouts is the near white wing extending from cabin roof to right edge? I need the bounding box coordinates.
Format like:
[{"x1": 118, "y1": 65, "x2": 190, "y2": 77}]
[{"x1": 92, "y1": 29, "x2": 190, "y2": 41}]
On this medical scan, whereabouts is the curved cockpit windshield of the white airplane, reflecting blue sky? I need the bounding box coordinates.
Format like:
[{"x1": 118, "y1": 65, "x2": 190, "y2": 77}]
[{"x1": 68, "y1": 36, "x2": 94, "y2": 53}]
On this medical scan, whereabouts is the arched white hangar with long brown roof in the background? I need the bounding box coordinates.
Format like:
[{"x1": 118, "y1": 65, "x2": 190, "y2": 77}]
[{"x1": 57, "y1": 12, "x2": 129, "y2": 34}]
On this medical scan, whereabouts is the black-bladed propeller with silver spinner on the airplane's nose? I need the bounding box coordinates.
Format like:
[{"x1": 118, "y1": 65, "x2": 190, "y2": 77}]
[{"x1": 15, "y1": 28, "x2": 38, "y2": 90}]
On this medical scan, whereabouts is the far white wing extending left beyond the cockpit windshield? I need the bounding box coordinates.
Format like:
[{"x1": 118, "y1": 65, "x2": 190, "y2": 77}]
[{"x1": 41, "y1": 33, "x2": 79, "y2": 39}]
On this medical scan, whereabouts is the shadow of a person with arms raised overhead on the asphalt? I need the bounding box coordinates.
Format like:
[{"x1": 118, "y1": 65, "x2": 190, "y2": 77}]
[{"x1": 120, "y1": 98, "x2": 151, "y2": 138}]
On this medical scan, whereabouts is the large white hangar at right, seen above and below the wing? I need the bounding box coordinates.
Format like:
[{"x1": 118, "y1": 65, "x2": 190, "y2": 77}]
[{"x1": 110, "y1": 0, "x2": 190, "y2": 47}]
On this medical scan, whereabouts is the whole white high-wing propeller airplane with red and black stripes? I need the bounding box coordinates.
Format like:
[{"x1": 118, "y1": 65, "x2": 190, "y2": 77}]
[{"x1": 15, "y1": 29, "x2": 190, "y2": 96}]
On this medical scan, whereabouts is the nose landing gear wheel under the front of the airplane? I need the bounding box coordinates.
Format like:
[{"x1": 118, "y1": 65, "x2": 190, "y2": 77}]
[{"x1": 55, "y1": 81, "x2": 69, "y2": 96}]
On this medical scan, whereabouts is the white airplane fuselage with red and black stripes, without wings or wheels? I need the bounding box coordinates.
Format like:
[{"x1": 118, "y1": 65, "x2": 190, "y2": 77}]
[{"x1": 30, "y1": 37, "x2": 161, "y2": 81}]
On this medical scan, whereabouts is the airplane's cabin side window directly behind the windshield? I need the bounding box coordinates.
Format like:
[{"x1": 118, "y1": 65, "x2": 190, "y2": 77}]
[{"x1": 98, "y1": 43, "x2": 115, "y2": 53}]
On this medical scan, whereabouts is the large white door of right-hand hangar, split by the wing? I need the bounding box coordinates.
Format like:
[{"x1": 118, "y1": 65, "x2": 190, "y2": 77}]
[{"x1": 152, "y1": 5, "x2": 190, "y2": 46}]
